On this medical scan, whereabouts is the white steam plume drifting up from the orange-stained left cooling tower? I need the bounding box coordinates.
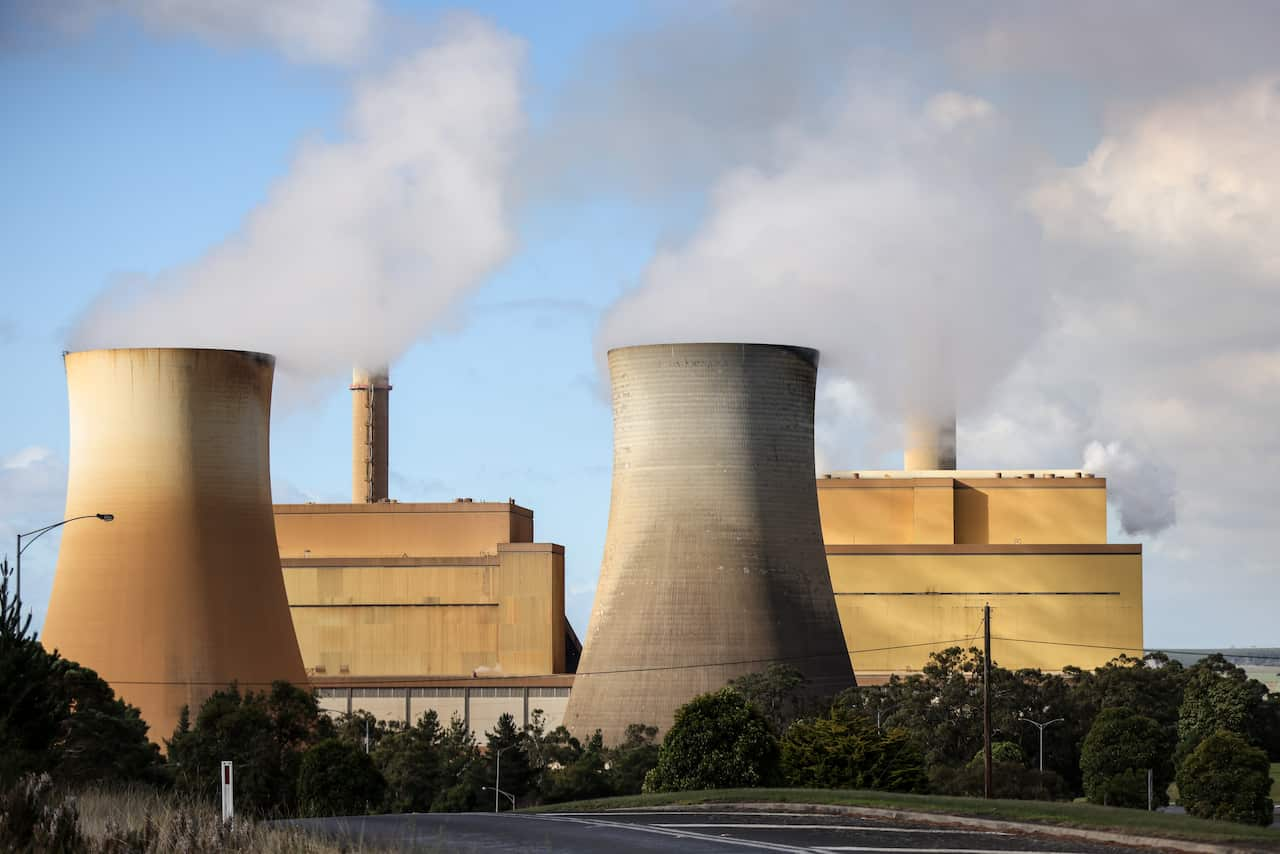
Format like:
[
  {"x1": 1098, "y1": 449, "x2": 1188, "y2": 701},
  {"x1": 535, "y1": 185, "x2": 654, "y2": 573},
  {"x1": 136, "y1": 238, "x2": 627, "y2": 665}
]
[{"x1": 70, "y1": 20, "x2": 522, "y2": 376}]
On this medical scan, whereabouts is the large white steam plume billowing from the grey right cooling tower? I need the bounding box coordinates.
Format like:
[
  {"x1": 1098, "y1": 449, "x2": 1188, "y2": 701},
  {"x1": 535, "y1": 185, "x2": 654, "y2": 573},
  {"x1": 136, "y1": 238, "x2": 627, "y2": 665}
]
[{"x1": 599, "y1": 90, "x2": 1046, "y2": 422}]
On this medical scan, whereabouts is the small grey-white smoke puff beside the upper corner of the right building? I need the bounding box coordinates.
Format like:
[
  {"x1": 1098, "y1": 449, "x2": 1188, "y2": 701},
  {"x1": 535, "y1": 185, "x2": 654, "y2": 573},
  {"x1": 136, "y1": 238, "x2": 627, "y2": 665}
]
[{"x1": 1083, "y1": 442, "x2": 1178, "y2": 535}]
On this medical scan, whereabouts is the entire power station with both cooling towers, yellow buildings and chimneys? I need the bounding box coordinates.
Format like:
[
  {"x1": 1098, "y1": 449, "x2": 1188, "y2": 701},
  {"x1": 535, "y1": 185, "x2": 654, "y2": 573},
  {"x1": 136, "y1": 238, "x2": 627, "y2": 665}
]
[{"x1": 44, "y1": 343, "x2": 1142, "y2": 741}]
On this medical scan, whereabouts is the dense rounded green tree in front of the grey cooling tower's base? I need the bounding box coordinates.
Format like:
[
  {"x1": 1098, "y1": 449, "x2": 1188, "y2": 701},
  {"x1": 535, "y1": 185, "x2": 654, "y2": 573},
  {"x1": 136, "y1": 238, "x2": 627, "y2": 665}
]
[{"x1": 644, "y1": 688, "x2": 780, "y2": 791}]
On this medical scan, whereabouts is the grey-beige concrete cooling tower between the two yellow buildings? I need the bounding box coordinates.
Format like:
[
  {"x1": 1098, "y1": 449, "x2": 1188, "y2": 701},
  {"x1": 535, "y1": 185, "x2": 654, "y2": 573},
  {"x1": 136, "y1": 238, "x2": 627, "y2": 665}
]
[{"x1": 564, "y1": 344, "x2": 854, "y2": 743}]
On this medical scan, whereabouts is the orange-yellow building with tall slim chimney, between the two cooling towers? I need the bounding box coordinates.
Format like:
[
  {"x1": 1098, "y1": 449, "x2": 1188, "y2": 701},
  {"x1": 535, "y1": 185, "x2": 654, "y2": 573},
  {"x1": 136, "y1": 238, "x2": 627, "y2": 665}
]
[{"x1": 275, "y1": 369, "x2": 581, "y2": 732}]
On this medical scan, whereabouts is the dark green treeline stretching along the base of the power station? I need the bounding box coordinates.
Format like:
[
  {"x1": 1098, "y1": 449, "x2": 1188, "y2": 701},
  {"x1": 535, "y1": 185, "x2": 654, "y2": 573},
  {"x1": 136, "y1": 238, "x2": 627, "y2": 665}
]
[{"x1": 0, "y1": 555, "x2": 1280, "y2": 842}]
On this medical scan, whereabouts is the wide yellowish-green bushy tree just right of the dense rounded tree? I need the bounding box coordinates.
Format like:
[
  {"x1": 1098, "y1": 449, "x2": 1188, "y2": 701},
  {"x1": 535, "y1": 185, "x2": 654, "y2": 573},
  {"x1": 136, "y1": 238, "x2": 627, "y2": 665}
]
[{"x1": 781, "y1": 704, "x2": 928, "y2": 793}]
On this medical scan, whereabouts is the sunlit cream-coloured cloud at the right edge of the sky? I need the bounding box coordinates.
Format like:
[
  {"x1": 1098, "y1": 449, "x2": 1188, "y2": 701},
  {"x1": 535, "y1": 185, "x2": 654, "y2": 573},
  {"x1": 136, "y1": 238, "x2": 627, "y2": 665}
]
[{"x1": 1033, "y1": 77, "x2": 1280, "y2": 277}]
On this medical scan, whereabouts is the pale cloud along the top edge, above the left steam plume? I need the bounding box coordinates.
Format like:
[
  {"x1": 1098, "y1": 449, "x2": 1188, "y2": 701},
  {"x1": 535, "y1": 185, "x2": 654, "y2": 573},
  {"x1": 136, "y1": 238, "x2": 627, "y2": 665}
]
[{"x1": 57, "y1": 0, "x2": 379, "y2": 65}]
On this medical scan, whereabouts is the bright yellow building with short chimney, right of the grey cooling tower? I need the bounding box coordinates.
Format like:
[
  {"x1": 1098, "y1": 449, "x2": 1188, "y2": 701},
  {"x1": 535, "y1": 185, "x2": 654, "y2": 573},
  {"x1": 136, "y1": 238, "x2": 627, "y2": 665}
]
[{"x1": 818, "y1": 419, "x2": 1142, "y2": 685}]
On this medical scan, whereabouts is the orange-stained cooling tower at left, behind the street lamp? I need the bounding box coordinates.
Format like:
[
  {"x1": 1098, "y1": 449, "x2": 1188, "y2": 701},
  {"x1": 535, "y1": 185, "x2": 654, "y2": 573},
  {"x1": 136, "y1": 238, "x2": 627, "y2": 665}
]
[{"x1": 44, "y1": 350, "x2": 306, "y2": 741}]
